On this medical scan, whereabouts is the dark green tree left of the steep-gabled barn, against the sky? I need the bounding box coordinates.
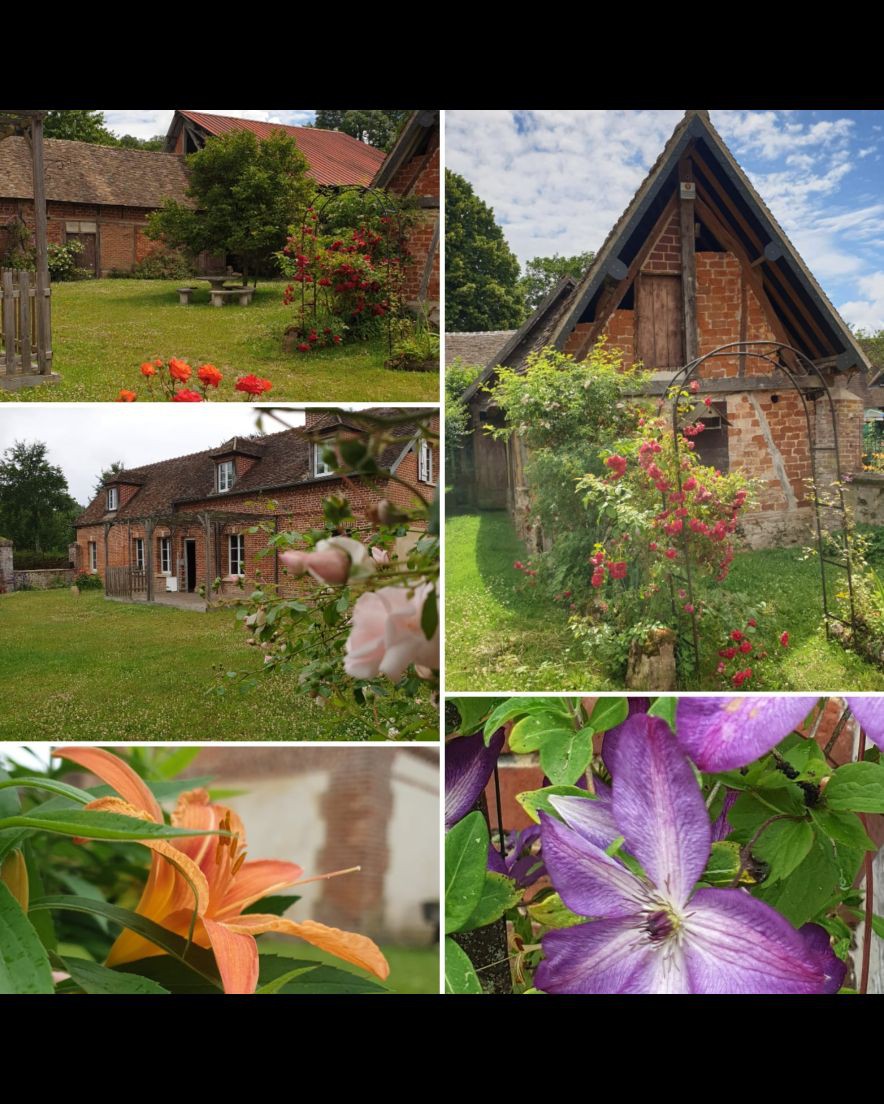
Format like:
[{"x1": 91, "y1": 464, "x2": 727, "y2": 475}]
[{"x1": 445, "y1": 169, "x2": 524, "y2": 331}]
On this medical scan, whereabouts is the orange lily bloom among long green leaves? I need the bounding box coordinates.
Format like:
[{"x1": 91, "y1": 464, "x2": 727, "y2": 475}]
[{"x1": 54, "y1": 747, "x2": 390, "y2": 992}]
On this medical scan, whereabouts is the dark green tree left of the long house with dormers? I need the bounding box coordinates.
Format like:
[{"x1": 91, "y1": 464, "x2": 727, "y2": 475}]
[{"x1": 0, "y1": 440, "x2": 82, "y2": 552}]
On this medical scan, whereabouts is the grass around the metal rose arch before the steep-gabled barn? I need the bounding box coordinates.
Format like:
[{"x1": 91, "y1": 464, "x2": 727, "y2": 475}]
[{"x1": 445, "y1": 512, "x2": 884, "y2": 692}]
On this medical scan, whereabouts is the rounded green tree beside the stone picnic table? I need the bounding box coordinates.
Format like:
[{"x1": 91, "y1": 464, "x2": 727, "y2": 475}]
[{"x1": 147, "y1": 130, "x2": 315, "y2": 286}]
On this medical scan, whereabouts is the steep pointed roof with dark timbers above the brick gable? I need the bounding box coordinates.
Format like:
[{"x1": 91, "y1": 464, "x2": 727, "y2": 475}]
[{"x1": 553, "y1": 110, "x2": 869, "y2": 371}]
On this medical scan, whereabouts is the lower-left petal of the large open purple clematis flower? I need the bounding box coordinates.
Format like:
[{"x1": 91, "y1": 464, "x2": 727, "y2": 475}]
[{"x1": 534, "y1": 915, "x2": 689, "y2": 994}]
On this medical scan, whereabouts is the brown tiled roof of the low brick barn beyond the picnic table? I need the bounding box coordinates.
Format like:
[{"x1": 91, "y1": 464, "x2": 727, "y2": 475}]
[{"x1": 0, "y1": 137, "x2": 192, "y2": 208}]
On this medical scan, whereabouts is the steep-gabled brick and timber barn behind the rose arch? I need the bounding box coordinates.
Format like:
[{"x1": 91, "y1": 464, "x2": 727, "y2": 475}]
[{"x1": 446, "y1": 110, "x2": 870, "y2": 549}]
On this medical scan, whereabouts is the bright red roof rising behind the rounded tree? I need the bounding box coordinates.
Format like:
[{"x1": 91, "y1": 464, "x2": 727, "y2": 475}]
[{"x1": 179, "y1": 110, "x2": 386, "y2": 185}]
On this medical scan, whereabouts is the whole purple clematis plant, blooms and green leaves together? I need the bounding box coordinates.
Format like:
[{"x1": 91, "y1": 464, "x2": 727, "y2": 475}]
[{"x1": 445, "y1": 697, "x2": 884, "y2": 994}]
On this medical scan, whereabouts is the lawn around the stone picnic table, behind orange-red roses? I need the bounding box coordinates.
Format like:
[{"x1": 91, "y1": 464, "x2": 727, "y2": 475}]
[{"x1": 0, "y1": 279, "x2": 439, "y2": 403}]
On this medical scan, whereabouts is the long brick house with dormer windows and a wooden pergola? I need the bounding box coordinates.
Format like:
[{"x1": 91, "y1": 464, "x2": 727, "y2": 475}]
[{"x1": 75, "y1": 414, "x2": 438, "y2": 602}]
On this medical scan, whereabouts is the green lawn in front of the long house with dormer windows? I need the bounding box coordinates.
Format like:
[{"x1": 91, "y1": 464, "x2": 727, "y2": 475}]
[{"x1": 0, "y1": 590, "x2": 428, "y2": 743}]
